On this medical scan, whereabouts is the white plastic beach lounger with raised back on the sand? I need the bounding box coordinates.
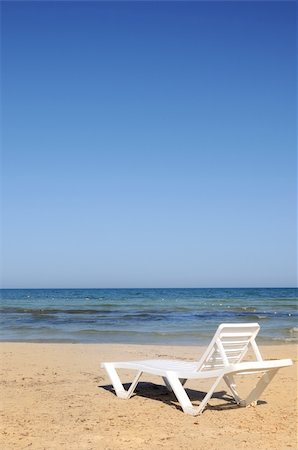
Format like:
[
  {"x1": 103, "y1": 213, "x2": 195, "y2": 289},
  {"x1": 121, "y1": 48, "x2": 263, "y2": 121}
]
[{"x1": 101, "y1": 323, "x2": 293, "y2": 416}]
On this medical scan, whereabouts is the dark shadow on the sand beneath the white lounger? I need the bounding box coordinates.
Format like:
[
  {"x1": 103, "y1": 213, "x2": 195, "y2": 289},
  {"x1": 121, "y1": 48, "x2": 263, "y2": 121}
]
[{"x1": 98, "y1": 382, "x2": 267, "y2": 411}]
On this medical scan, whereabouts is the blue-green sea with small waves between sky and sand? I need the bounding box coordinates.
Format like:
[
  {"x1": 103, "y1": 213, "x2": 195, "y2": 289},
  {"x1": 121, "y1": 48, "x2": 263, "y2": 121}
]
[{"x1": 0, "y1": 288, "x2": 298, "y2": 345}]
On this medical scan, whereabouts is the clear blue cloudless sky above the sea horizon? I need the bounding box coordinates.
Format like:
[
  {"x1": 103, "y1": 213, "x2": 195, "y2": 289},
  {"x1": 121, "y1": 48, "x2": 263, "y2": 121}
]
[{"x1": 1, "y1": 2, "x2": 297, "y2": 287}]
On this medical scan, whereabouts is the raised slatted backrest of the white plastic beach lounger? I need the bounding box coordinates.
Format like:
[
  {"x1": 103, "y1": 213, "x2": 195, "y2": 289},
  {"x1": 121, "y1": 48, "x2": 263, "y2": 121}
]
[{"x1": 198, "y1": 323, "x2": 262, "y2": 371}]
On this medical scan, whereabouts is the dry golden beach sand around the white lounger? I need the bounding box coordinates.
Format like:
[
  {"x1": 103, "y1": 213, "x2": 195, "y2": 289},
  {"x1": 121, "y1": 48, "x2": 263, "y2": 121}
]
[{"x1": 0, "y1": 343, "x2": 297, "y2": 450}]
